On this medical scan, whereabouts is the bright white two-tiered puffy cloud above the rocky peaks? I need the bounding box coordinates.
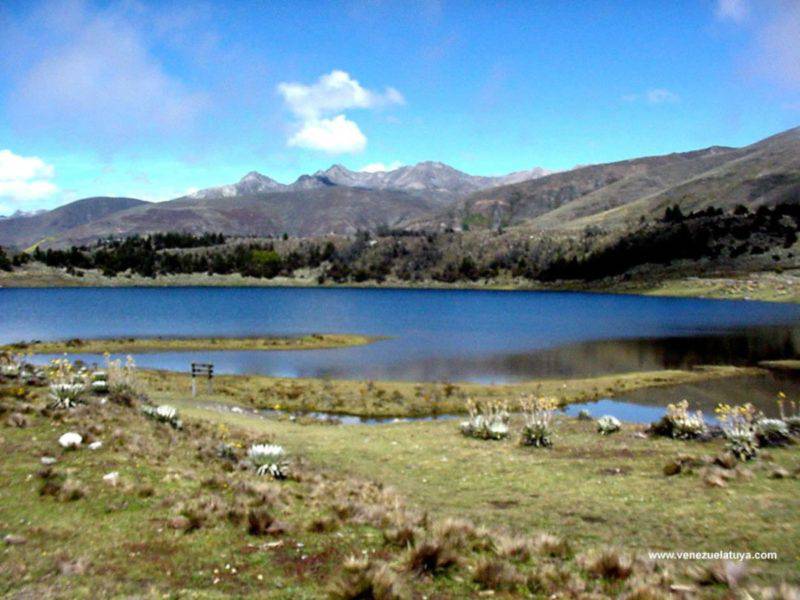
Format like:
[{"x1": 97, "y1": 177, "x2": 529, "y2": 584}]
[{"x1": 278, "y1": 70, "x2": 405, "y2": 154}]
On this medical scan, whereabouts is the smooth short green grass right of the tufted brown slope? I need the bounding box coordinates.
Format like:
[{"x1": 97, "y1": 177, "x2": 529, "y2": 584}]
[{"x1": 172, "y1": 402, "x2": 800, "y2": 583}]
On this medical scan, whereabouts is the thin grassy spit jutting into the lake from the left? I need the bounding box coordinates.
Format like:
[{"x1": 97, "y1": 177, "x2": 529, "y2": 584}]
[{"x1": 0, "y1": 333, "x2": 379, "y2": 354}]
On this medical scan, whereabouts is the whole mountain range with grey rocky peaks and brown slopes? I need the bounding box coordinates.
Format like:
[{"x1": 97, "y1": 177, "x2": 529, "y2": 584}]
[{"x1": 0, "y1": 128, "x2": 800, "y2": 248}]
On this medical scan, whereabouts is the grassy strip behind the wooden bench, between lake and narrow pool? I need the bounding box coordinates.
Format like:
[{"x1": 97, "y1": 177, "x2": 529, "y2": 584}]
[{"x1": 142, "y1": 367, "x2": 760, "y2": 417}]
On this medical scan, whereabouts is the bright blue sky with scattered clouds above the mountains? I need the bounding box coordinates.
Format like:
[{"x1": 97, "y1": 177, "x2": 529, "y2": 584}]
[{"x1": 0, "y1": 0, "x2": 800, "y2": 215}]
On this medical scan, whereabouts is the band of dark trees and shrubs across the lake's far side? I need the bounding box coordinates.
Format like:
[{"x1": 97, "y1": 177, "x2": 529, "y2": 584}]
[{"x1": 0, "y1": 204, "x2": 800, "y2": 283}]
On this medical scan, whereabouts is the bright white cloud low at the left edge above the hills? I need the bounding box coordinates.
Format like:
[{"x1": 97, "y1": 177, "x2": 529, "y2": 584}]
[{"x1": 0, "y1": 150, "x2": 58, "y2": 206}]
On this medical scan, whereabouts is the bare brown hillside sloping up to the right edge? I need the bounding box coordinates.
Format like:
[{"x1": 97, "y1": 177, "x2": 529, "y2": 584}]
[{"x1": 438, "y1": 128, "x2": 800, "y2": 230}]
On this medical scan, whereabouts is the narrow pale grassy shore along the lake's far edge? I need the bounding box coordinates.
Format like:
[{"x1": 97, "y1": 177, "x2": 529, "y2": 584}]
[{"x1": 0, "y1": 265, "x2": 800, "y2": 302}]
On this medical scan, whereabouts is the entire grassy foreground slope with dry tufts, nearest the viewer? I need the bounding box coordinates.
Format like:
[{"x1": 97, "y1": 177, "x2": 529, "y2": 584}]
[{"x1": 0, "y1": 372, "x2": 800, "y2": 599}]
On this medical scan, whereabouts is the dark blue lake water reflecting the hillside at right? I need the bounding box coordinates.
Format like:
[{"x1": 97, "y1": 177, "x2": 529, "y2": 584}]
[{"x1": 0, "y1": 288, "x2": 800, "y2": 383}]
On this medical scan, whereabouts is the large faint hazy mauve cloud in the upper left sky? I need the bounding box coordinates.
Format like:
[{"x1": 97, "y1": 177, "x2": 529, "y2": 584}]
[{"x1": 10, "y1": 2, "x2": 206, "y2": 141}]
